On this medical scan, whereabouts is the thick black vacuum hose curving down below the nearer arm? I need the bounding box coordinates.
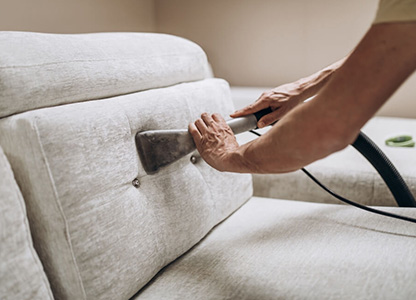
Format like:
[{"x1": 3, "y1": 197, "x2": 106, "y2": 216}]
[{"x1": 352, "y1": 132, "x2": 416, "y2": 207}]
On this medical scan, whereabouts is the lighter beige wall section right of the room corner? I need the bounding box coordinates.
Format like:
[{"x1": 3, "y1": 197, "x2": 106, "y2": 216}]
[{"x1": 155, "y1": 0, "x2": 416, "y2": 118}]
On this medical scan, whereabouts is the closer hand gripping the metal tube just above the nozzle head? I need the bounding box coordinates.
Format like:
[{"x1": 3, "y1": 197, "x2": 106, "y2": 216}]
[{"x1": 188, "y1": 113, "x2": 239, "y2": 171}]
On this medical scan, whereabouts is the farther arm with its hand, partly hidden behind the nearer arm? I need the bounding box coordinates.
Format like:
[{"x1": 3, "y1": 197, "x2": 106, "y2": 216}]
[{"x1": 230, "y1": 56, "x2": 348, "y2": 128}]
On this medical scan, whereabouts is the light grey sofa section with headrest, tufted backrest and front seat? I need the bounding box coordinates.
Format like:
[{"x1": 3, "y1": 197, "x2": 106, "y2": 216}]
[{"x1": 0, "y1": 32, "x2": 416, "y2": 300}]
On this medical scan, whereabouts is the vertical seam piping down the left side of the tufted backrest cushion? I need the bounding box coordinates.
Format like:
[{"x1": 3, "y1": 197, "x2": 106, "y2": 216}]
[{"x1": 33, "y1": 118, "x2": 87, "y2": 300}]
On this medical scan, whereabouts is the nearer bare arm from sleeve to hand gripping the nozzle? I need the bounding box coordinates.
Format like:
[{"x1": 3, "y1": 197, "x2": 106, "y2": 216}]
[{"x1": 189, "y1": 22, "x2": 416, "y2": 173}]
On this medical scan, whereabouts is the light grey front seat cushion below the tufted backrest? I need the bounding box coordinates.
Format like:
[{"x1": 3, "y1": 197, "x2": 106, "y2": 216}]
[{"x1": 134, "y1": 197, "x2": 416, "y2": 300}]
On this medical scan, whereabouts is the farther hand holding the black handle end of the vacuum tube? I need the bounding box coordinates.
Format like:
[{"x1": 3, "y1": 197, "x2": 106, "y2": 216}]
[{"x1": 230, "y1": 82, "x2": 305, "y2": 128}]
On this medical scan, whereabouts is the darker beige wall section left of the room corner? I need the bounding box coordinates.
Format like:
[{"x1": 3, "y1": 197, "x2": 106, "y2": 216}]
[{"x1": 0, "y1": 0, "x2": 155, "y2": 33}]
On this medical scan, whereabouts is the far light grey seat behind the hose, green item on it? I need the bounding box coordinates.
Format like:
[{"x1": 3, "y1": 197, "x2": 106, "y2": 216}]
[{"x1": 242, "y1": 117, "x2": 416, "y2": 206}]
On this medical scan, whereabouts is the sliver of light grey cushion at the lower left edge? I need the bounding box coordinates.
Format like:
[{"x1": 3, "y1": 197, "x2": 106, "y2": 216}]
[{"x1": 0, "y1": 147, "x2": 53, "y2": 300}]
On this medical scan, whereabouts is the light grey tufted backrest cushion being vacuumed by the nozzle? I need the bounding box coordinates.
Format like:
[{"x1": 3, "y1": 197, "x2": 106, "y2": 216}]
[{"x1": 0, "y1": 79, "x2": 252, "y2": 300}]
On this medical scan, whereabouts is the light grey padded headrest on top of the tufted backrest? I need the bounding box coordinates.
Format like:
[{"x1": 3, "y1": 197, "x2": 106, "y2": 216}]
[{"x1": 0, "y1": 31, "x2": 209, "y2": 117}]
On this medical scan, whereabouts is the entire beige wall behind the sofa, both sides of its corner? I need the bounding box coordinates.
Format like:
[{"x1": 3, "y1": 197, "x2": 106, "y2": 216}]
[{"x1": 0, "y1": 0, "x2": 416, "y2": 118}]
